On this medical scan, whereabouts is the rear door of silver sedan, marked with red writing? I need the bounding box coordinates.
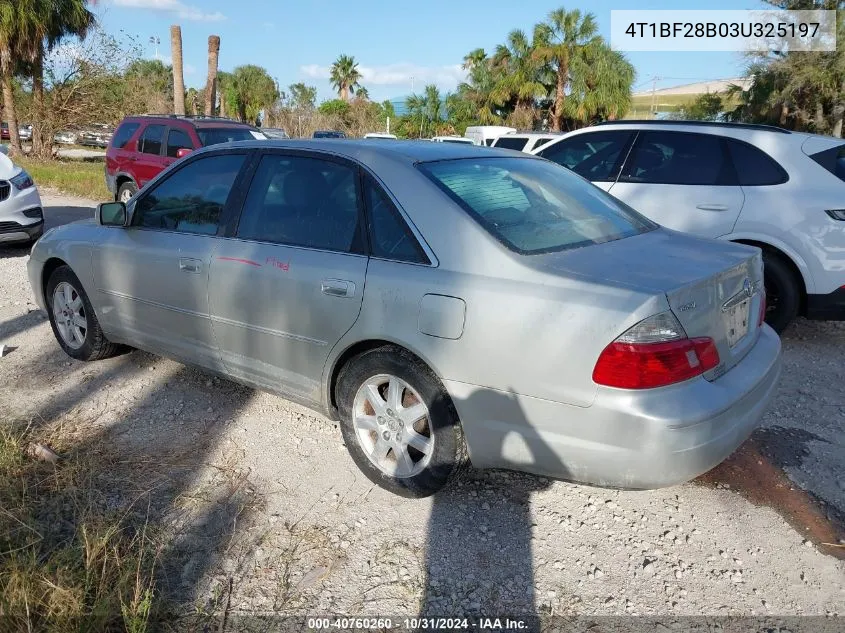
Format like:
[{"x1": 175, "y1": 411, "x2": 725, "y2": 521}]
[{"x1": 208, "y1": 151, "x2": 368, "y2": 402}]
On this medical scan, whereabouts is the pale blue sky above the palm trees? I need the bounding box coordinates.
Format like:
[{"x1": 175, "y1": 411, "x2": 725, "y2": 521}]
[{"x1": 93, "y1": 0, "x2": 763, "y2": 101}]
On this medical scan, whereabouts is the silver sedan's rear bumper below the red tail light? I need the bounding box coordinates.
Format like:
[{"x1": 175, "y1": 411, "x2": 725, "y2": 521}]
[{"x1": 446, "y1": 326, "x2": 780, "y2": 489}]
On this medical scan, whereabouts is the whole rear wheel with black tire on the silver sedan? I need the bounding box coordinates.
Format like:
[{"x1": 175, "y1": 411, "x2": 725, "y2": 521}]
[{"x1": 335, "y1": 346, "x2": 467, "y2": 498}]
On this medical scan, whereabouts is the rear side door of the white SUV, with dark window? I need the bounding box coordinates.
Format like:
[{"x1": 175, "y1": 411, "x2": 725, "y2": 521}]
[{"x1": 610, "y1": 130, "x2": 745, "y2": 237}]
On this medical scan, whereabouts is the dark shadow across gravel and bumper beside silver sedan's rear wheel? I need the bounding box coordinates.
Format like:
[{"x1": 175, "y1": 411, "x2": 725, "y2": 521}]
[{"x1": 420, "y1": 390, "x2": 566, "y2": 632}]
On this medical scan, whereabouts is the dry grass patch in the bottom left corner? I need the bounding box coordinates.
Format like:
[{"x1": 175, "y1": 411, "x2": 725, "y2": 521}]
[{"x1": 0, "y1": 423, "x2": 160, "y2": 633}]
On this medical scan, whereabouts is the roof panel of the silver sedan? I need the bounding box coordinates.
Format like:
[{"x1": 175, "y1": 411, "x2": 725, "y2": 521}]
[{"x1": 198, "y1": 138, "x2": 535, "y2": 165}]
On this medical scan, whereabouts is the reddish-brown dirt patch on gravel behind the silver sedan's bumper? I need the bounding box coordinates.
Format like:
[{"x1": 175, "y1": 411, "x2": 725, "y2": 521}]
[{"x1": 696, "y1": 426, "x2": 845, "y2": 559}]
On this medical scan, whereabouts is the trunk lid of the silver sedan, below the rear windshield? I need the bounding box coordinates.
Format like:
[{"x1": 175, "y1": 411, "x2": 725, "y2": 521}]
[{"x1": 531, "y1": 228, "x2": 764, "y2": 380}]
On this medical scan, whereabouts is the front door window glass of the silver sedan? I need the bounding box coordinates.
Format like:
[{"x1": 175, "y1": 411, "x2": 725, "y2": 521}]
[{"x1": 132, "y1": 154, "x2": 245, "y2": 235}]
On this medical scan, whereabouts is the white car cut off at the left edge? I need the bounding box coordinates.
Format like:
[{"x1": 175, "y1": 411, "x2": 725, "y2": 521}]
[{"x1": 0, "y1": 152, "x2": 44, "y2": 244}]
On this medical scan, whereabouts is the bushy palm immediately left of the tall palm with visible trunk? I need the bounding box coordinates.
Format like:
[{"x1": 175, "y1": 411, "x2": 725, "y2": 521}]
[{"x1": 492, "y1": 29, "x2": 546, "y2": 123}]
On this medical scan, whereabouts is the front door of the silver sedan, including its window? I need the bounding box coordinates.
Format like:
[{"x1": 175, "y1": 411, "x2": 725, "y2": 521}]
[{"x1": 93, "y1": 150, "x2": 247, "y2": 369}]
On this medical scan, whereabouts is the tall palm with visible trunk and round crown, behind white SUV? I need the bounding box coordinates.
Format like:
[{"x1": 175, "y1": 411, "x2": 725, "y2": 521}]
[{"x1": 534, "y1": 9, "x2": 599, "y2": 132}]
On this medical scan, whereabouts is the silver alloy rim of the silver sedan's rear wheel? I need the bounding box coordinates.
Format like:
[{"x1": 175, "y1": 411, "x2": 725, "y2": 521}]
[{"x1": 352, "y1": 374, "x2": 434, "y2": 479}]
